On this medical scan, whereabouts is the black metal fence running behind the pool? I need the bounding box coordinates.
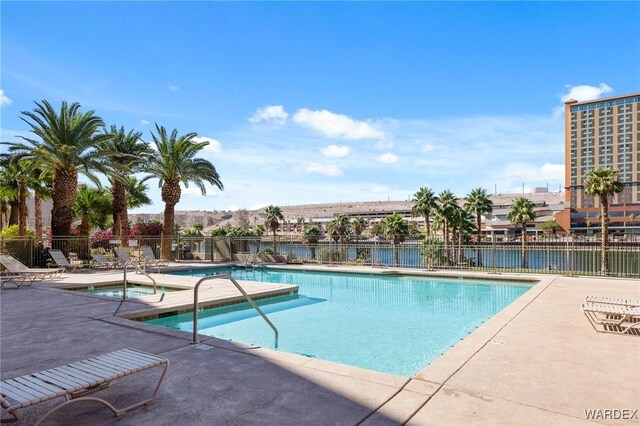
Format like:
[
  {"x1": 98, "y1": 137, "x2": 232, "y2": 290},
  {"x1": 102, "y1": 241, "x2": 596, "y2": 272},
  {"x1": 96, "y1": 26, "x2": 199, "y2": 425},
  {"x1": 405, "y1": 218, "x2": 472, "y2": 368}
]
[{"x1": 0, "y1": 236, "x2": 640, "y2": 277}]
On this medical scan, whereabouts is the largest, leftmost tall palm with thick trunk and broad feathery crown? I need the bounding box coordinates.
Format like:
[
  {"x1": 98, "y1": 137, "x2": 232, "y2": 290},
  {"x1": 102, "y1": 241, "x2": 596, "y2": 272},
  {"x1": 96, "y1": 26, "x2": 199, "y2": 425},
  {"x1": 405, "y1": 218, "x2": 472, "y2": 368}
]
[{"x1": 4, "y1": 100, "x2": 110, "y2": 240}]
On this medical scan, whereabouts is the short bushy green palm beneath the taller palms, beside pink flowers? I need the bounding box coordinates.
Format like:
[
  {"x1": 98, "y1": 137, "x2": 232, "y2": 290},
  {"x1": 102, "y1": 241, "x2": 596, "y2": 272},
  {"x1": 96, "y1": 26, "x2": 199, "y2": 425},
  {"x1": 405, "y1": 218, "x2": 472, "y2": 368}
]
[{"x1": 73, "y1": 185, "x2": 111, "y2": 259}]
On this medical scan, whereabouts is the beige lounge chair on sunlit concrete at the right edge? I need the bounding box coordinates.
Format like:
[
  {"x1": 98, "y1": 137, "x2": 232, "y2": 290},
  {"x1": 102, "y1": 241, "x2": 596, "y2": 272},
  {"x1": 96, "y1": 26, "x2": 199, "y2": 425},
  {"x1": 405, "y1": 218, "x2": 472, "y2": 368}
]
[{"x1": 582, "y1": 303, "x2": 640, "y2": 334}]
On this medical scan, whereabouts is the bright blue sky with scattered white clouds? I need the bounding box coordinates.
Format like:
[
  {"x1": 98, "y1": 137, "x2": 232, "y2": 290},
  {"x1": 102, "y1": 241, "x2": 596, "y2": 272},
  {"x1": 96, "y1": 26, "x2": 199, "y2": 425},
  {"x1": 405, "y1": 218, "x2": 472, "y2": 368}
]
[{"x1": 0, "y1": 2, "x2": 640, "y2": 212}]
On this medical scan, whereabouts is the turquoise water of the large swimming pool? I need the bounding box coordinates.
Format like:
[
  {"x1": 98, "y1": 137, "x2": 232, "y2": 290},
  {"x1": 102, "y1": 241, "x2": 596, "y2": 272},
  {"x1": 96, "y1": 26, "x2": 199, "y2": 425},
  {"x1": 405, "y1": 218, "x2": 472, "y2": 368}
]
[{"x1": 146, "y1": 268, "x2": 531, "y2": 376}]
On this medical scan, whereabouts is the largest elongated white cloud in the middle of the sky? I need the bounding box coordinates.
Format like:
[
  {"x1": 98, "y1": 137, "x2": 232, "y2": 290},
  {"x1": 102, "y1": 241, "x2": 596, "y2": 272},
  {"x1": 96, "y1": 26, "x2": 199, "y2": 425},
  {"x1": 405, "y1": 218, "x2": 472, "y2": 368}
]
[{"x1": 293, "y1": 108, "x2": 385, "y2": 140}]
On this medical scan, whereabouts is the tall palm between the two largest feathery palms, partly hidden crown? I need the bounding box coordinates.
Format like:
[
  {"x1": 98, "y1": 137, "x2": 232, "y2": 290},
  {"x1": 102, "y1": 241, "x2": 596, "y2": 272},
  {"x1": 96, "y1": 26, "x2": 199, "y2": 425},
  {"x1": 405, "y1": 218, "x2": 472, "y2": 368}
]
[{"x1": 102, "y1": 126, "x2": 150, "y2": 246}]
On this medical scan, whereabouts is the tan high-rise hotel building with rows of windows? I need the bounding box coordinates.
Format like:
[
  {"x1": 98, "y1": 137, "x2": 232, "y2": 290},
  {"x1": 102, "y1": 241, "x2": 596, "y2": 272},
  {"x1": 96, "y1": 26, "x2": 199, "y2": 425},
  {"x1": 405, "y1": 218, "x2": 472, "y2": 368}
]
[{"x1": 558, "y1": 93, "x2": 640, "y2": 234}]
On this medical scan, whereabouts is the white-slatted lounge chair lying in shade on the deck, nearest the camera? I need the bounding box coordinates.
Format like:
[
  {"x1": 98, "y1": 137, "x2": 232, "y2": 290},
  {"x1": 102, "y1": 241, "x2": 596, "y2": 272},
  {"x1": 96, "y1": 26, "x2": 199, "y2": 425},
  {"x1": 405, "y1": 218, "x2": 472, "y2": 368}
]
[{"x1": 0, "y1": 349, "x2": 169, "y2": 424}]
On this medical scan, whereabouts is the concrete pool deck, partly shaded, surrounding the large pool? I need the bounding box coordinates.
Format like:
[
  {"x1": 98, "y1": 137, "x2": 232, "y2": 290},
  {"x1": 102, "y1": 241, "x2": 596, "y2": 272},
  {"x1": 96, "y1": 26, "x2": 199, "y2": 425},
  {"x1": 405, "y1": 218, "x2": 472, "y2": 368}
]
[{"x1": 0, "y1": 266, "x2": 640, "y2": 425}]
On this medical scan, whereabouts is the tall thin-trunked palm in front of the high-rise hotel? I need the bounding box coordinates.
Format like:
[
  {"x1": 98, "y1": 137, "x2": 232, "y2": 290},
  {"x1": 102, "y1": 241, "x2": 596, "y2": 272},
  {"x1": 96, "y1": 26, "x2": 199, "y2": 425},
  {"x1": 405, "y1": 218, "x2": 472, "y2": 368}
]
[{"x1": 584, "y1": 167, "x2": 624, "y2": 275}]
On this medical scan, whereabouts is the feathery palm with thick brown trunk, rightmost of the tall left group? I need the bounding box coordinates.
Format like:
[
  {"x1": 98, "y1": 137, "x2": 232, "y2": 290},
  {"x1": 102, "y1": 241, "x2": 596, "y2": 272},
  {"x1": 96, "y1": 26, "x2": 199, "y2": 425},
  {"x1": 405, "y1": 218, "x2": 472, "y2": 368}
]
[{"x1": 141, "y1": 124, "x2": 223, "y2": 259}]
